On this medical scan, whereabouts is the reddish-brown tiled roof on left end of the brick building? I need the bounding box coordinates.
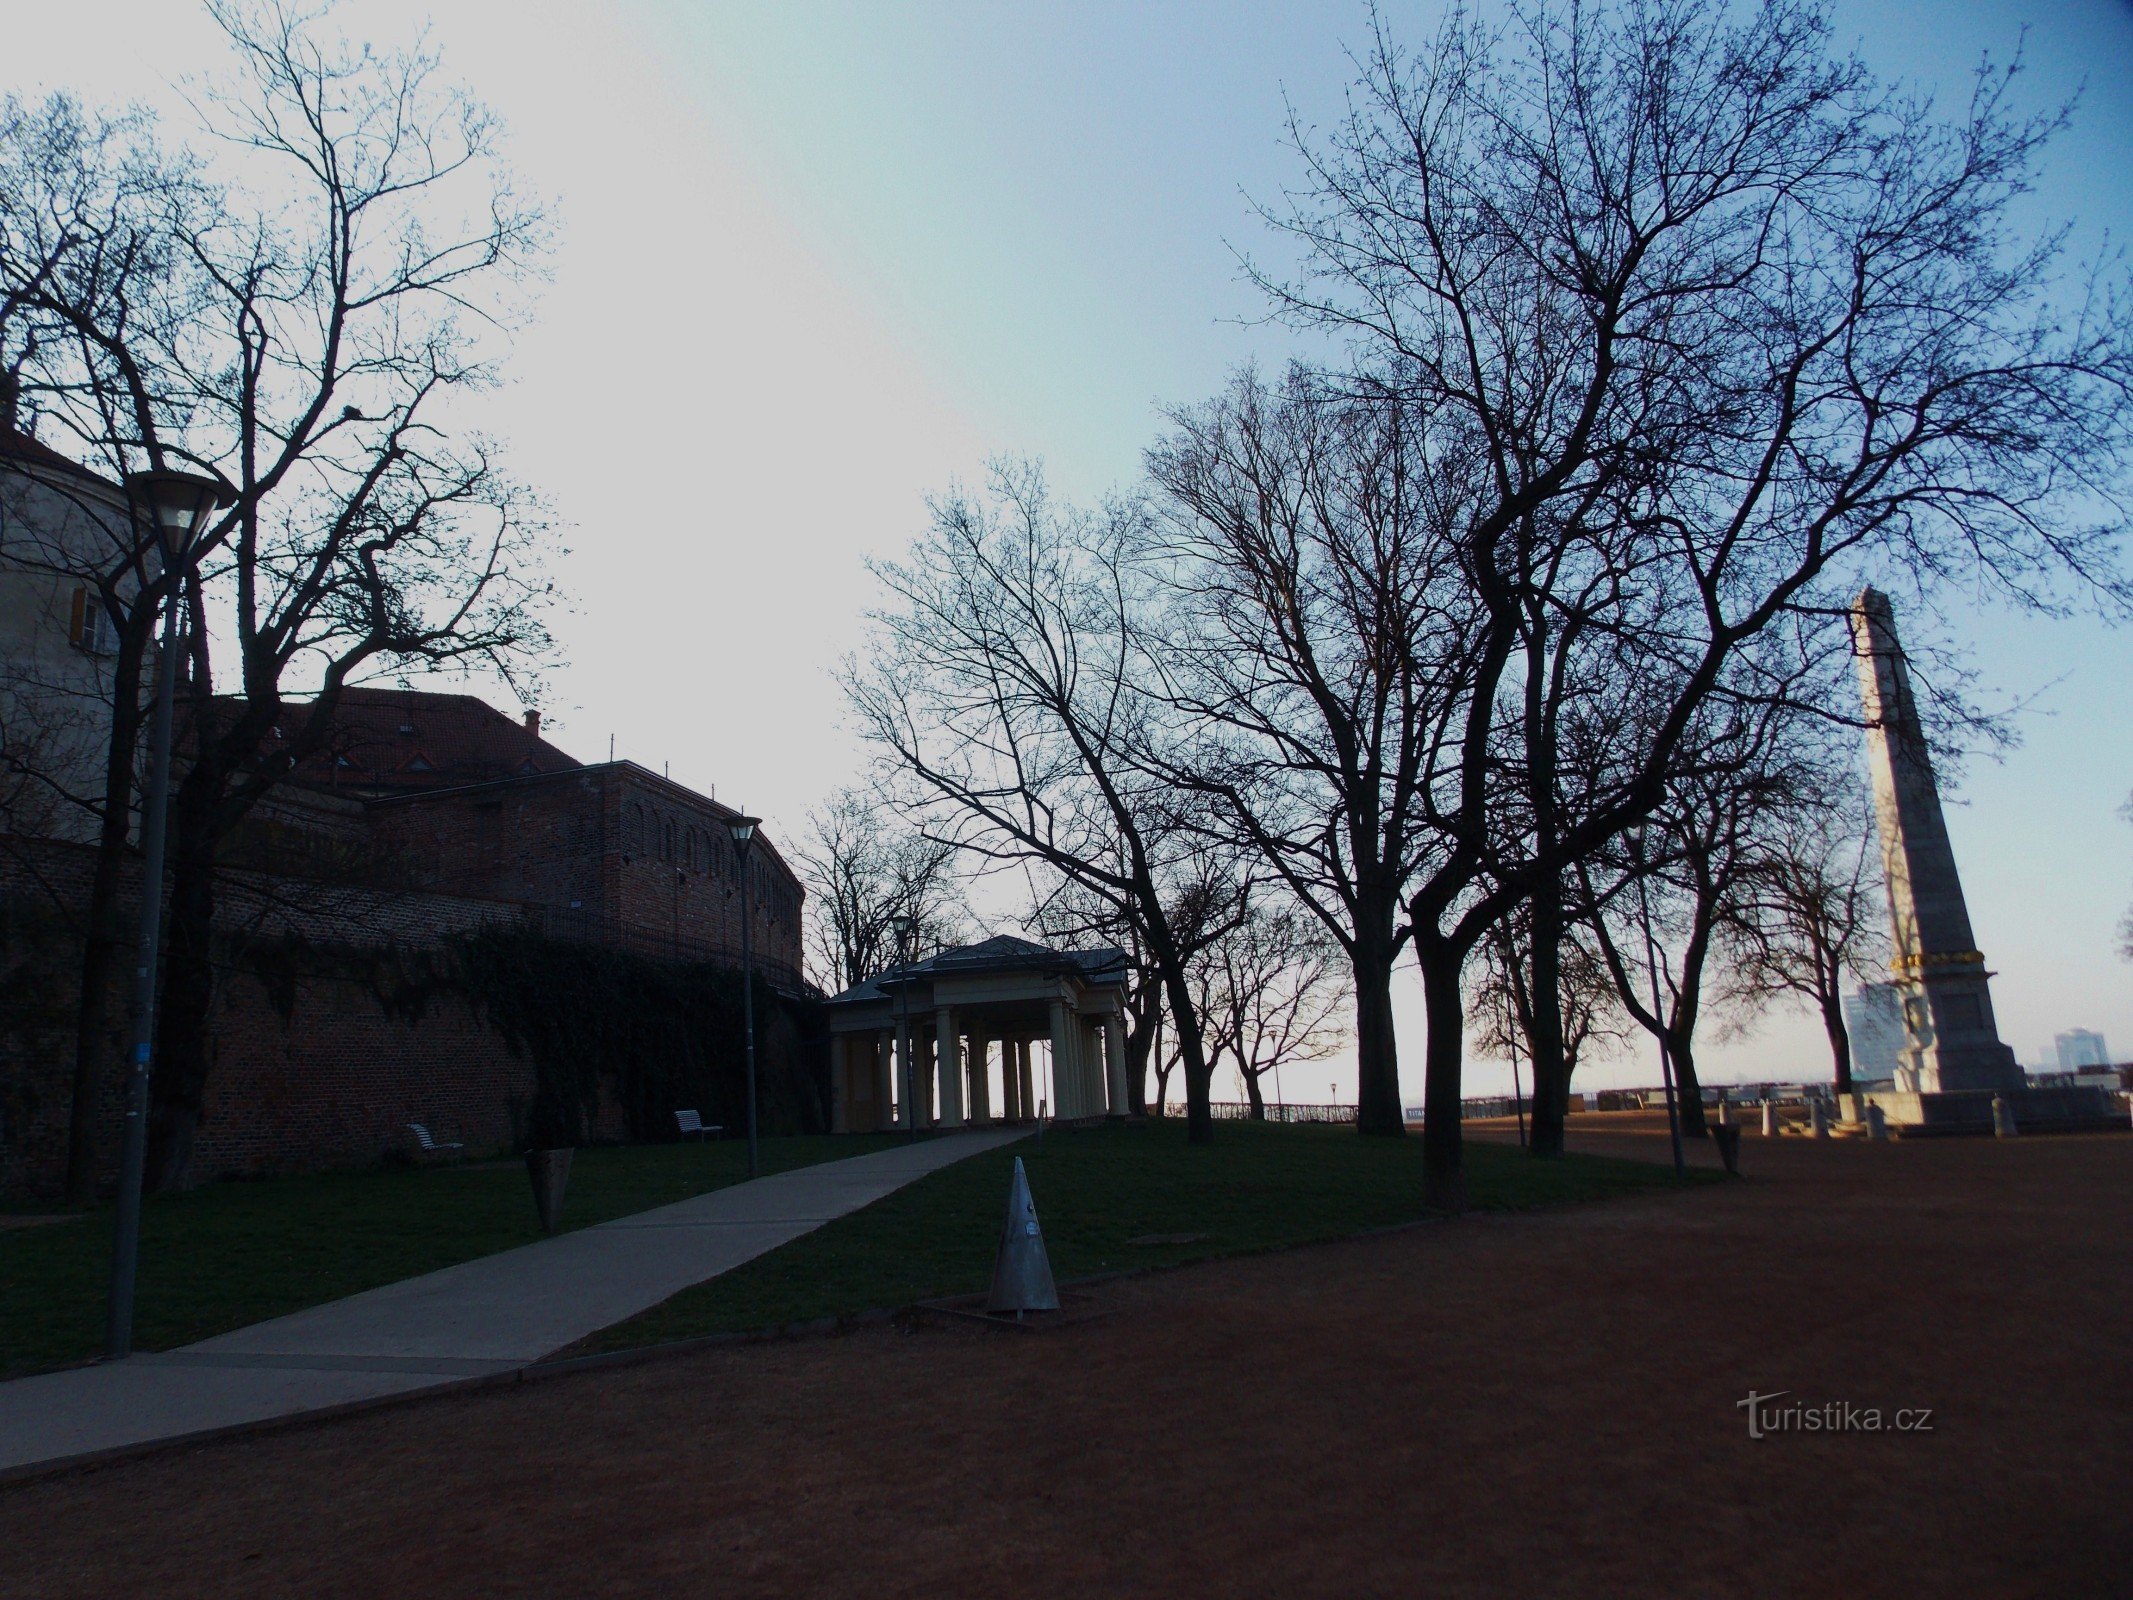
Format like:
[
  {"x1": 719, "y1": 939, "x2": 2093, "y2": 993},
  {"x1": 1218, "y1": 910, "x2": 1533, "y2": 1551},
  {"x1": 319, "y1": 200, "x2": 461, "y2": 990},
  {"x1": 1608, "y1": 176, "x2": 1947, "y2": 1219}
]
[{"x1": 244, "y1": 689, "x2": 584, "y2": 794}]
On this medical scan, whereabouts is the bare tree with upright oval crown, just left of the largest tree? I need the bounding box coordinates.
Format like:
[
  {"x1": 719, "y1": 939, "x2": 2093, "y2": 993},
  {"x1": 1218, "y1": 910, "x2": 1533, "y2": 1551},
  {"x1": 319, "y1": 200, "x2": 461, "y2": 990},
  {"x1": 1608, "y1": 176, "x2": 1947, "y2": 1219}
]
[{"x1": 1148, "y1": 371, "x2": 1472, "y2": 1135}]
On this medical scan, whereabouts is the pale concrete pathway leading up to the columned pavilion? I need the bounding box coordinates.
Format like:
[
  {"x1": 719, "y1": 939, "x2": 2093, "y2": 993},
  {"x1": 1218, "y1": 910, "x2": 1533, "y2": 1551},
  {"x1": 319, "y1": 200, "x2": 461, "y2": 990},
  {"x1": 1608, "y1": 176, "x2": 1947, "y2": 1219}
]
[{"x1": 0, "y1": 1129, "x2": 1026, "y2": 1472}]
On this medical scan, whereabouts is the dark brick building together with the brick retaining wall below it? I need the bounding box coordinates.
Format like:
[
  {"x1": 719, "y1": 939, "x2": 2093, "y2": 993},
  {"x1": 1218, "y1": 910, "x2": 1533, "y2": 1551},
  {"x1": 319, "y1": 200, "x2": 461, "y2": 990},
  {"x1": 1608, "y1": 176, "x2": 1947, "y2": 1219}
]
[{"x1": 0, "y1": 691, "x2": 810, "y2": 1193}]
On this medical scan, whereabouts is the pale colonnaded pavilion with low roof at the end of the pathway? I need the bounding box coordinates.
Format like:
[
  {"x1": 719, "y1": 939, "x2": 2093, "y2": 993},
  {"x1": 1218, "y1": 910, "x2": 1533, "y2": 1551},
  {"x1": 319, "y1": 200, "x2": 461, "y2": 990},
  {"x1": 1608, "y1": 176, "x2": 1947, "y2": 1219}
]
[{"x1": 830, "y1": 934, "x2": 1128, "y2": 1133}]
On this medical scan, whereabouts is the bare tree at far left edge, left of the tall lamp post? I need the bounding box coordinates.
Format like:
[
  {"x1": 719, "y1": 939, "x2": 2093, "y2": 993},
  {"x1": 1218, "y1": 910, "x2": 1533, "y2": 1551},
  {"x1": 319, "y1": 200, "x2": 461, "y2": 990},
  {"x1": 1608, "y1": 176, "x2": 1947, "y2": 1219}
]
[{"x1": 0, "y1": 94, "x2": 218, "y2": 1203}]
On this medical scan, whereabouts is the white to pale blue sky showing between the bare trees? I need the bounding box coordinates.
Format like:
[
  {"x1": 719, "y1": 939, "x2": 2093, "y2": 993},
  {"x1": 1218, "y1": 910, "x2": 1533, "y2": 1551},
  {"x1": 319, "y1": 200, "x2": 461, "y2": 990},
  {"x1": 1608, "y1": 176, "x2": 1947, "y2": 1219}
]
[{"x1": 0, "y1": 0, "x2": 2133, "y2": 1101}]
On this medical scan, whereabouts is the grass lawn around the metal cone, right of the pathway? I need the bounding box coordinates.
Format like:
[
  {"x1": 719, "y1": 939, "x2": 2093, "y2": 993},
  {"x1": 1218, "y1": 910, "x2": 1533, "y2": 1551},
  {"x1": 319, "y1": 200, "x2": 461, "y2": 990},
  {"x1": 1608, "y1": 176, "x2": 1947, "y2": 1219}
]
[{"x1": 572, "y1": 1118, "x2": 1717, "y2": 1355}]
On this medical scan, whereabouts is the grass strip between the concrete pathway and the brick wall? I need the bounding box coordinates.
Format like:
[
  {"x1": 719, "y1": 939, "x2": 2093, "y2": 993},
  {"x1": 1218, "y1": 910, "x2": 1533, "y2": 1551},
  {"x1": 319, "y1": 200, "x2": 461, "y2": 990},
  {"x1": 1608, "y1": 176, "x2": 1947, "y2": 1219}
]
[{"x1": 0, "y1": 1135, "x2": 892, "y2": 1378}]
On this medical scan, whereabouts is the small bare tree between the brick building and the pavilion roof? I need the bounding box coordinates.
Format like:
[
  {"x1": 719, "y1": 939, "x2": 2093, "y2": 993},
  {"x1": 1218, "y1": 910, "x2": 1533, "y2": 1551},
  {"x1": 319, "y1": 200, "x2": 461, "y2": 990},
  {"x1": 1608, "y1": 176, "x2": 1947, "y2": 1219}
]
[{"x1": 793, "y1": 785, "x2": 968, "y2": 994}]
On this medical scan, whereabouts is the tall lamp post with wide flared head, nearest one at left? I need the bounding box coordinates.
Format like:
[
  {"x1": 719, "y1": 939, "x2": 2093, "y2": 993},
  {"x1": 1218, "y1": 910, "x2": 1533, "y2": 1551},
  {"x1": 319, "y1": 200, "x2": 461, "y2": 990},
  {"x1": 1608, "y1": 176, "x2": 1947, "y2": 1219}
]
[{"x1": 105, "y1": 471, "x2": 237, "y2": 1361}]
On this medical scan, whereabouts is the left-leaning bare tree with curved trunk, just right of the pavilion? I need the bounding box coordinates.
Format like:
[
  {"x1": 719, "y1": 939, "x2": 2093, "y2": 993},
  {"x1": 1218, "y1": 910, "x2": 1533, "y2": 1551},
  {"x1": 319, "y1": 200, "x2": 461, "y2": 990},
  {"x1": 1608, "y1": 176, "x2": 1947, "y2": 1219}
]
[{"x1": 845, "y1": 465, "x2": 1214, "y2": 1143}]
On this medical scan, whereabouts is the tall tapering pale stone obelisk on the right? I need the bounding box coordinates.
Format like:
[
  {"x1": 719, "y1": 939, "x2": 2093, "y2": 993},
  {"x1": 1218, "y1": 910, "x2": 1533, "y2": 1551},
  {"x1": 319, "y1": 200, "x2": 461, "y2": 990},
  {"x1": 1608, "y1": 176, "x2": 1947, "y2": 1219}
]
[{"x1": 1851, "y1": 589, "x2": 2026, "y2": 1094}]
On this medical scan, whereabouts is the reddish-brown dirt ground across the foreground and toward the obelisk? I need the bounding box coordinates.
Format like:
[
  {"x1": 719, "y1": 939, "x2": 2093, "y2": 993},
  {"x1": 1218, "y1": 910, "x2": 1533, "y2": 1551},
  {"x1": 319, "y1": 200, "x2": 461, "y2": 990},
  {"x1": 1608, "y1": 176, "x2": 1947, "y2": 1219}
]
[{"x1": 0, "y1": 1118, "x2": 2133, "y2": 1600}]
